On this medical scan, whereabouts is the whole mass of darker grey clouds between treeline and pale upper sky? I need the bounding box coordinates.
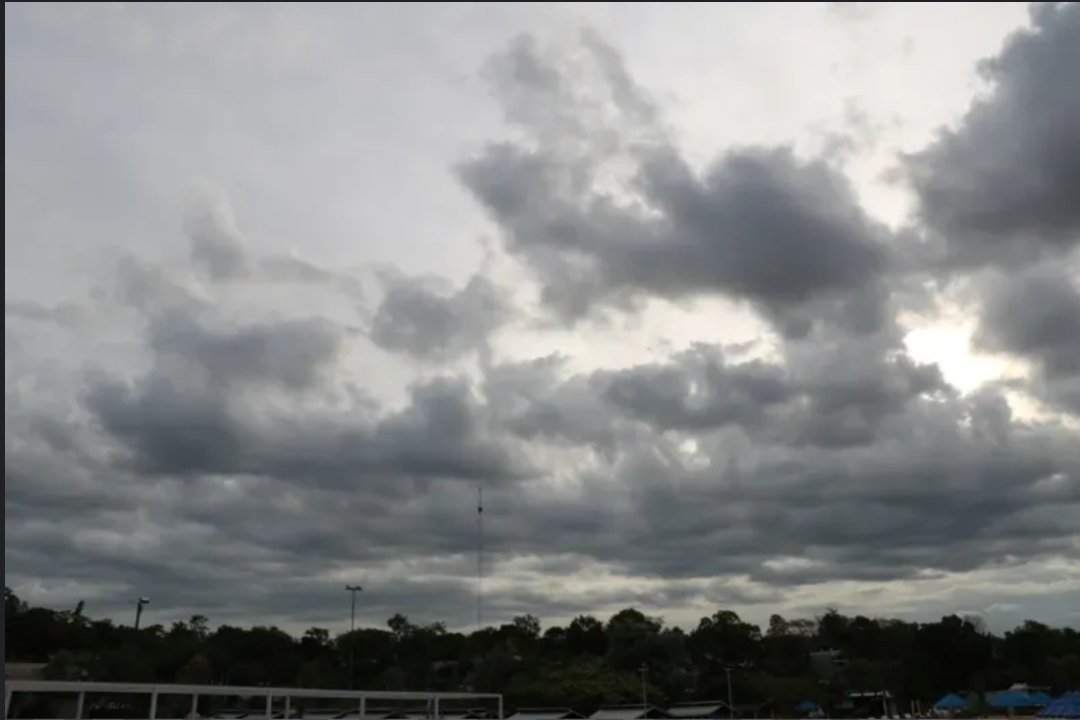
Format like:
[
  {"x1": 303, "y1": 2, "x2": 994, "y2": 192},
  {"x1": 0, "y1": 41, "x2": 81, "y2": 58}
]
[{"x1": 4, "y1": 3, "x2": 1080, "y2": 625}]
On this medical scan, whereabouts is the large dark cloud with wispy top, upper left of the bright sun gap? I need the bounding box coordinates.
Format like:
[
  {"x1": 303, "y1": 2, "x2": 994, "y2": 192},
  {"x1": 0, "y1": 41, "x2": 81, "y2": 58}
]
[{"x1": 460, "y1": 36, "x2": 891, "y2": 336}]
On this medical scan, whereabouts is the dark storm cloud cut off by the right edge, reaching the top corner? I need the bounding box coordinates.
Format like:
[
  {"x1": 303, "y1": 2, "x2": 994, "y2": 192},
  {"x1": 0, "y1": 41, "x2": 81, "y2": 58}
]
[{"x1": 906, "y1": 3, "x2": 1080, "y2": 412}]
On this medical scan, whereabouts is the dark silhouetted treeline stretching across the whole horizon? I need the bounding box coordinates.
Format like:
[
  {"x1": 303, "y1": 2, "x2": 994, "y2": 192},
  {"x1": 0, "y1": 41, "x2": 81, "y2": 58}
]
[{"x1": 4, "y1": 588, "x2": 1080, "y2": 711}]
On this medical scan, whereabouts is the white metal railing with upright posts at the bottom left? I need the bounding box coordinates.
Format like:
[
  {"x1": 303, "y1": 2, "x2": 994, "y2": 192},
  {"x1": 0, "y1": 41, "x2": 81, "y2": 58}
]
[{"x1": 3, "y1": 679, "x2": 503, "y2": 720}]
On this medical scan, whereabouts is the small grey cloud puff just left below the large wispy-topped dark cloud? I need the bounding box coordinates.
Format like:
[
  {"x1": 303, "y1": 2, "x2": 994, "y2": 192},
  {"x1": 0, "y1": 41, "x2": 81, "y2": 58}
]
[{"x1": 370, "y1": 274, "x2": 510, "y2": 361}]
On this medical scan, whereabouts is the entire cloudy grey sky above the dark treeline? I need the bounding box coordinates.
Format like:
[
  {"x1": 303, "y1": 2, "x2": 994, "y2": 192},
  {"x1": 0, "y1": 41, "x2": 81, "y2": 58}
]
[{"x1": 4, "y1": 2, "x2": 1080, "y2": 630}]
